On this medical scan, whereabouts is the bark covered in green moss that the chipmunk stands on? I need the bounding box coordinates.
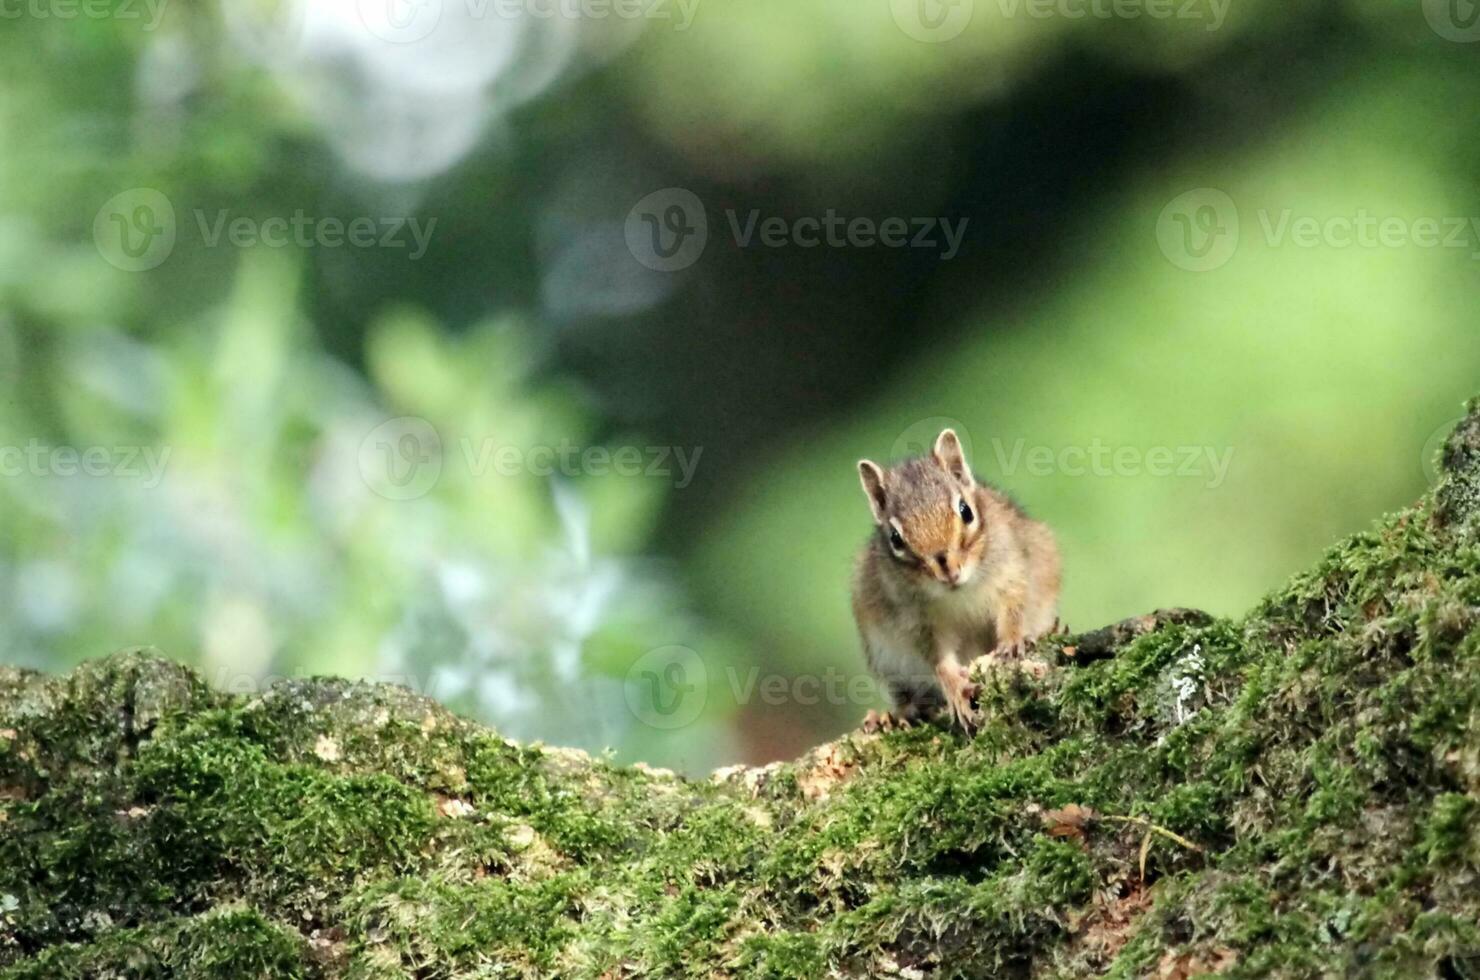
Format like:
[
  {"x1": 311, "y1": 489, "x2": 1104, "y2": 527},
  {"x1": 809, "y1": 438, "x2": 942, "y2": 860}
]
[{"x1": 0, "y1": 407, "x2": 1480, "y2": 980}]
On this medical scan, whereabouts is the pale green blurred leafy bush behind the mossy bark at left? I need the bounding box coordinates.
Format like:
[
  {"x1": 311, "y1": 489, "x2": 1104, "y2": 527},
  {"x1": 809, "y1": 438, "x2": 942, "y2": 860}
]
[{"x1": 0, "y1": 250, "x2": 731, "y2": 769}]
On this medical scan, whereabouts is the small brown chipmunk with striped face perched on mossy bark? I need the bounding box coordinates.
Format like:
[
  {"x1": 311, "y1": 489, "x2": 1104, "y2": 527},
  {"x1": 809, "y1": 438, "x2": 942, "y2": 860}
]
[{"x1": 852, "y1": 429, "x2": 1060, "y2": 731}]
